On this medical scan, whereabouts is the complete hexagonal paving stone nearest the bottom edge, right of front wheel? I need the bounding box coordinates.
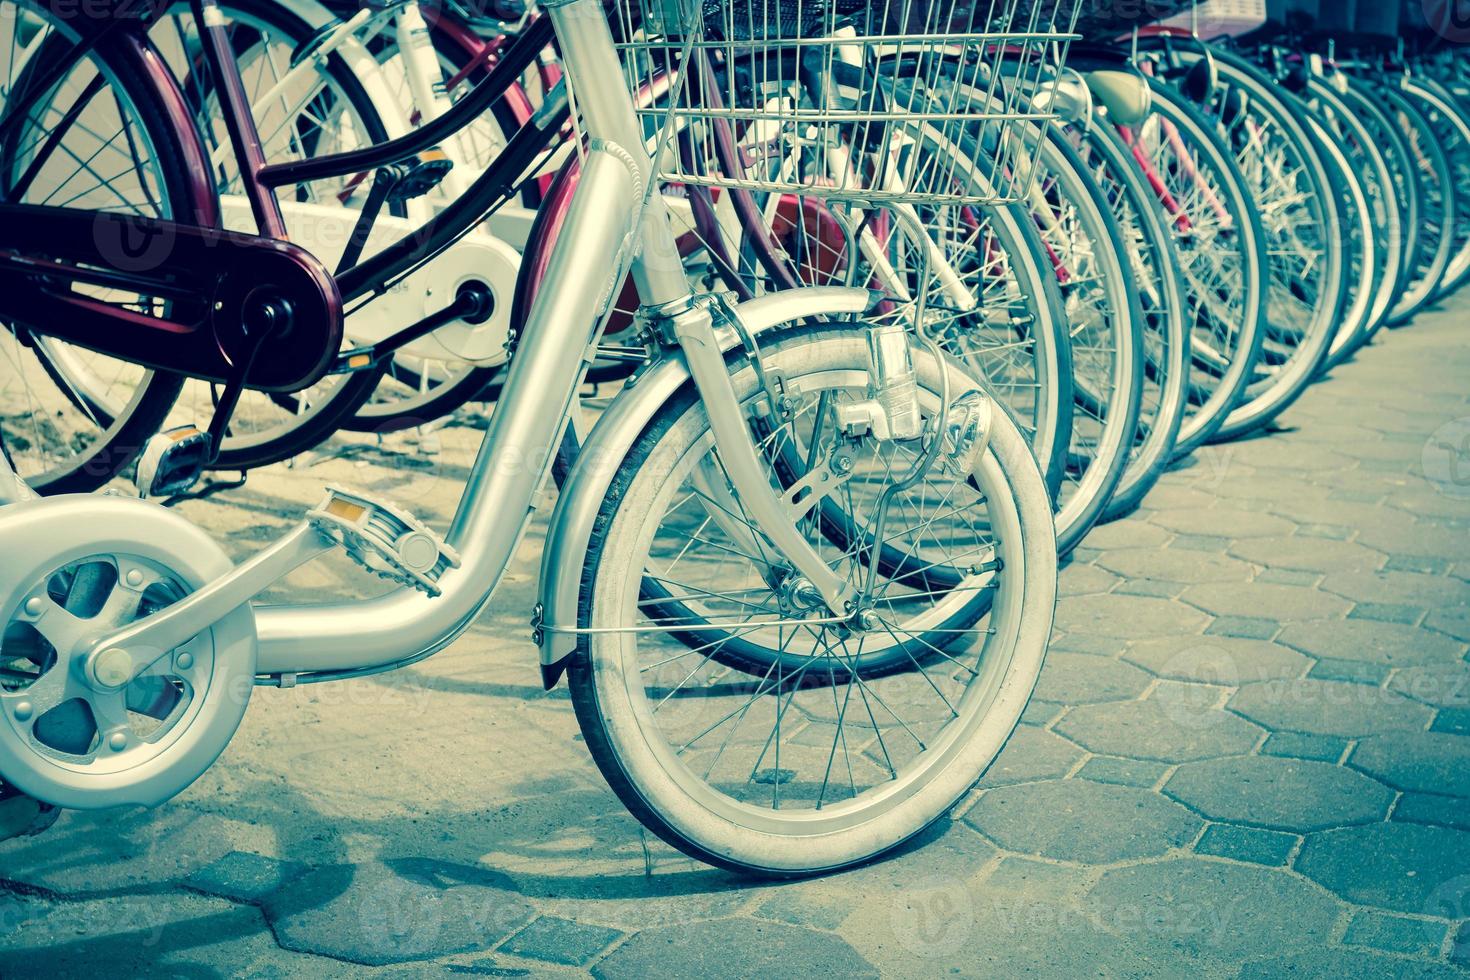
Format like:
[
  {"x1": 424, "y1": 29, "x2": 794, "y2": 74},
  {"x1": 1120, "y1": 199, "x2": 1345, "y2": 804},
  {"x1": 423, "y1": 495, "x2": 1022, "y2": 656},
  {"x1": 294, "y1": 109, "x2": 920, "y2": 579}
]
[{"x1": 1085, "y1": 858, "x2": 1339, "y2": 959}]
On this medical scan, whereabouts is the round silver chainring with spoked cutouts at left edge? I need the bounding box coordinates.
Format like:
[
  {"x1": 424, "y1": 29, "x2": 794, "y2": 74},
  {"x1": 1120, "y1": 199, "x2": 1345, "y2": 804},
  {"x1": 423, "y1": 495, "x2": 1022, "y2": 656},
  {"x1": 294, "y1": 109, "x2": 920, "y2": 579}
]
[{"x1": 0, "y1": 495, "x2": 257, "y2": 810}]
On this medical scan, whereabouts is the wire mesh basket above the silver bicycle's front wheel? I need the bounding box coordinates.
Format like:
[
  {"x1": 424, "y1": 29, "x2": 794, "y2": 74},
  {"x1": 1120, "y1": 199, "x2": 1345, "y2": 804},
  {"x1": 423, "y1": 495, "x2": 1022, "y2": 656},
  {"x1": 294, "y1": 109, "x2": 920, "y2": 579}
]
[{"x1": 614, "y1": 0, "x2": 1080, "y2": 204}]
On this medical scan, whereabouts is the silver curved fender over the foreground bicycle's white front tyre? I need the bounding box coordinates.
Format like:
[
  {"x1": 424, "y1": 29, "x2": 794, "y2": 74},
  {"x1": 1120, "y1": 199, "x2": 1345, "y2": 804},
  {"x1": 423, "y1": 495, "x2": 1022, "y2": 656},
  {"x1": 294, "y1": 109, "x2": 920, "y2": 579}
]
[{"x1": 534, "y1": 287, "x2": 873, "y2": 689}]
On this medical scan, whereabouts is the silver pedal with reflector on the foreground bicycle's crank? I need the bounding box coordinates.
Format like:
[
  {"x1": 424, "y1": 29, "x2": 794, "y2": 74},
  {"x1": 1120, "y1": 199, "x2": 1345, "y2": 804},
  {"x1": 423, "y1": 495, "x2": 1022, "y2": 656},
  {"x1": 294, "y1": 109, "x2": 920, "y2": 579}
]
[{"x1": 306, "y1": 486, "x2": 460, "y2": 595}]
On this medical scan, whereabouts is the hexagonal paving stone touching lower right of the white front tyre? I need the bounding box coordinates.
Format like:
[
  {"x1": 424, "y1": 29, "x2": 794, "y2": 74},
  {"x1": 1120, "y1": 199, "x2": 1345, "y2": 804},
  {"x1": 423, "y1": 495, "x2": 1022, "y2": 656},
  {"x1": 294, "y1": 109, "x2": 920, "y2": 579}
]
[{"x1": 964, "y1": 779, "x2": 1204, "y2": 864}]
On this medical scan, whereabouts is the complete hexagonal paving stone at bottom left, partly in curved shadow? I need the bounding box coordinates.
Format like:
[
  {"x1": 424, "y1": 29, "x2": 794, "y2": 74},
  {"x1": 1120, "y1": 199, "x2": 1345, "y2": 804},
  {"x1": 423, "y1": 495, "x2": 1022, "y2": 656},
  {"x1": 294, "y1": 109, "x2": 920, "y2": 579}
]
[{"x1": 265, "y1": 858, "x2": 535, "y2": 965}]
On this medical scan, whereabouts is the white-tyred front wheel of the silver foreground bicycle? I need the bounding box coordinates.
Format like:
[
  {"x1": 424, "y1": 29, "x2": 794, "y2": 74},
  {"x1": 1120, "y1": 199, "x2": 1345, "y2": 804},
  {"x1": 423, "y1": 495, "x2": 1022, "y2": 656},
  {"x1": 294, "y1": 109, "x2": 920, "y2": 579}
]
[{"x1": 569, "y1": 328, "x2": 1057, "y2": 876}]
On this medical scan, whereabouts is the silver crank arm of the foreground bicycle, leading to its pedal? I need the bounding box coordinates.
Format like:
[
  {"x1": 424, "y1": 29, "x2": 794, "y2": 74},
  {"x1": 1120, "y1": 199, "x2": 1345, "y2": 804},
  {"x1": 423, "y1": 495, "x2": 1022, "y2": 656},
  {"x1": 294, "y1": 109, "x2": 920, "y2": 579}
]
[{"x1": 85, "y1": 522, "x2": 338, "y2": 688}]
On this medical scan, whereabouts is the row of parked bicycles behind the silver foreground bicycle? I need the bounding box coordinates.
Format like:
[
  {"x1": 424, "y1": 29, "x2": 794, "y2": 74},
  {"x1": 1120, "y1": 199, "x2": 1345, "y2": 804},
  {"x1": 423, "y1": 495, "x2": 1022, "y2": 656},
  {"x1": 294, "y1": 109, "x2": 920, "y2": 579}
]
[{"x1": 3, "y1": 0, "x2": 1470, "y2": 551}]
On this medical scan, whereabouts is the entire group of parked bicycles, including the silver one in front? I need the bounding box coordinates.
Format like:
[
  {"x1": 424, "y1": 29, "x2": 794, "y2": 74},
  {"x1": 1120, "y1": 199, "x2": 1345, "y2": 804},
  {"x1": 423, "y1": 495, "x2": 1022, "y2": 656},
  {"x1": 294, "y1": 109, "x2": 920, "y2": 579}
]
[{"x1": 0, "y1": 0, "x2": 1470, "y2": 874}]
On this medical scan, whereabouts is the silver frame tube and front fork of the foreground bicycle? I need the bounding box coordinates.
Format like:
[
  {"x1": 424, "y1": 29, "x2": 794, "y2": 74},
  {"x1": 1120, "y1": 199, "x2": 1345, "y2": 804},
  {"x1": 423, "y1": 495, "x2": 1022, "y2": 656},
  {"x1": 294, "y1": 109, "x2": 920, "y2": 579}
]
[{"x1": 194, "y1": 0, "x2": 867, "y2": 676}]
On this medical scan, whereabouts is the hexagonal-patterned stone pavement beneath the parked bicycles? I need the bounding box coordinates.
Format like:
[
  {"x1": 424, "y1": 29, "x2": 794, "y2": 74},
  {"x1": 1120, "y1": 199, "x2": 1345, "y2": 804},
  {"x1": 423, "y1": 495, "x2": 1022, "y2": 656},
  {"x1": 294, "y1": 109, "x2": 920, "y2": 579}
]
[{"x1": 0, "y1": 300, "x2": 1470, "y2": 977}]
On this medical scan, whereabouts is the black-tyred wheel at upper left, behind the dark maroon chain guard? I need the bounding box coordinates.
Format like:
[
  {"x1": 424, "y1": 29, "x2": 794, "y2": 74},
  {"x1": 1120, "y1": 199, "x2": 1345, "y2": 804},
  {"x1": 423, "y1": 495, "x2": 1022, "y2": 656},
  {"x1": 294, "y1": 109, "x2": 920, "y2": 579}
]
[{"x1": 0, "y1": 0, "x2": 198, "y2": 494}]
